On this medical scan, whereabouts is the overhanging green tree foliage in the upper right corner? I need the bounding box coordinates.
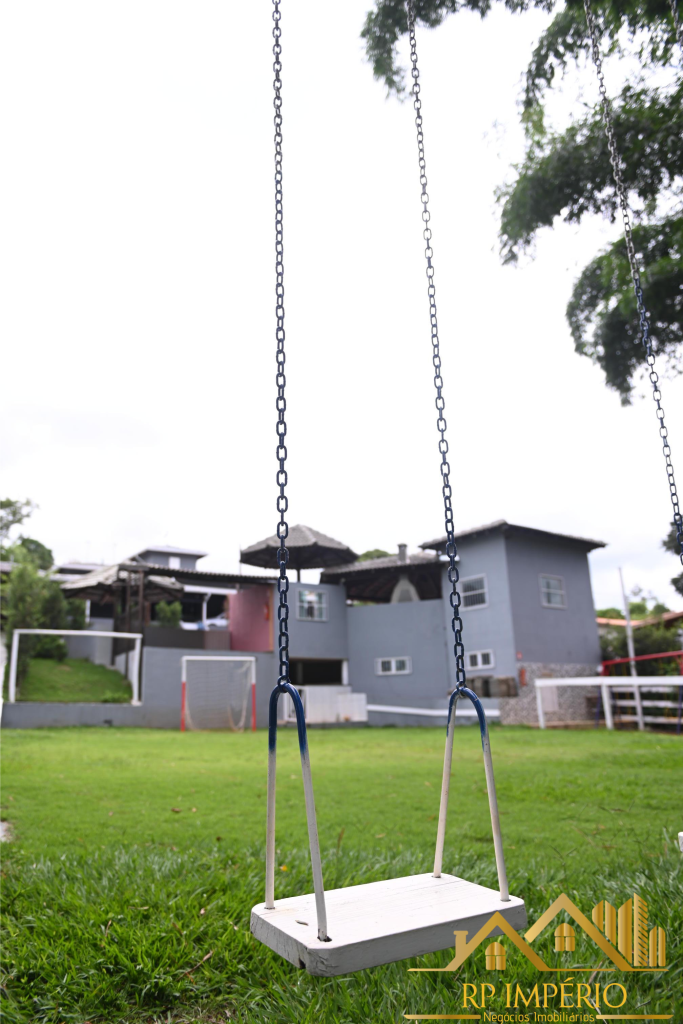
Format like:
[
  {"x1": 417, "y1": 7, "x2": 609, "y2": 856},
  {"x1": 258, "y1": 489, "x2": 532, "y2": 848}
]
[{"x1": 361, "y1": 0, "x2": 683, "y2": 403}]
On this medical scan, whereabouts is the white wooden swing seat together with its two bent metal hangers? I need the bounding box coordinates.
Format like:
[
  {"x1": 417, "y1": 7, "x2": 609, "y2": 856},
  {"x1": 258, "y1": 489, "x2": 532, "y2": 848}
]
[{"x1": 251, "y1": 683, "x2": 526, "y2": 977}]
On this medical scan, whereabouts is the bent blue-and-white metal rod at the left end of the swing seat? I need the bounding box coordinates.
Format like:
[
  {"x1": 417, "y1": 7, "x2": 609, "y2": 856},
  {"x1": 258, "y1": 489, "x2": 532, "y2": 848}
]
[{"x1": 265, "y1": 683, "x2": 329, "y2": 942}]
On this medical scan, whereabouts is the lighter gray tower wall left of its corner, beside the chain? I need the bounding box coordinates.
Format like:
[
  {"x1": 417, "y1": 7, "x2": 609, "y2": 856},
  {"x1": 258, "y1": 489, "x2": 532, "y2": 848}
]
[{"x1": 442, "y1": 534, "x2": 517, "y2": 688}]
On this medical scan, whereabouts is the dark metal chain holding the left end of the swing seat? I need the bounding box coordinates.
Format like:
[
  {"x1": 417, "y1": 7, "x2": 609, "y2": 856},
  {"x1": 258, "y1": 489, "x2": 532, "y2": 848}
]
[{"x1": 272, "y1": 0, "x2": 290, "y2": 687}]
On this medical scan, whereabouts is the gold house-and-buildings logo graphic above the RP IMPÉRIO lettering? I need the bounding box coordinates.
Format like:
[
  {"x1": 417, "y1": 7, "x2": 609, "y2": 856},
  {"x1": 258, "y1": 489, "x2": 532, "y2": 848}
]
[{"x1": 409, "y1": 893, "x2": 668, "y2": 974}]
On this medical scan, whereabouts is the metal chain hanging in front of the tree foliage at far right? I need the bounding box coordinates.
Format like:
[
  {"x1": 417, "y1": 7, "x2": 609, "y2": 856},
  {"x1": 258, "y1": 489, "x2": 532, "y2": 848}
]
[{"x1": 584, "y1": 0, "x2": 683, "y2": 565}]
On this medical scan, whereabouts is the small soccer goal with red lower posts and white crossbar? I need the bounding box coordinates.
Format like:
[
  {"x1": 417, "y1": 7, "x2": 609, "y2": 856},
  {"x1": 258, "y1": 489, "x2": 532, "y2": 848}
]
[{"x1": 180, "y1": 654, "x2": 256, "y2": 732}]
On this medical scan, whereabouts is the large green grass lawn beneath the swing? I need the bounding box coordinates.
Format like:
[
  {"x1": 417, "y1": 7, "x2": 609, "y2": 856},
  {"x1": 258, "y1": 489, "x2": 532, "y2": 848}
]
[{"x1": 0, "y1": 728, "x2": 683, "y2": 1024}]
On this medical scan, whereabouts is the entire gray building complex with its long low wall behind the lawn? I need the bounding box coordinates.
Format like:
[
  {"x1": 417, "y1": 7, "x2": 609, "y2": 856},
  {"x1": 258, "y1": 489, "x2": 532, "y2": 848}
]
[{"x1": 3, "y1": 520, "x2": 603, "y2": 728}]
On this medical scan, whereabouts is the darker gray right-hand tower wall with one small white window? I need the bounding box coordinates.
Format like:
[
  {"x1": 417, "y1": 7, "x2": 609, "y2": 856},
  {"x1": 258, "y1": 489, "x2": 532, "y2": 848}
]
[{"x1": 505, "y1": 537, "x2": 600, "y2": 669}]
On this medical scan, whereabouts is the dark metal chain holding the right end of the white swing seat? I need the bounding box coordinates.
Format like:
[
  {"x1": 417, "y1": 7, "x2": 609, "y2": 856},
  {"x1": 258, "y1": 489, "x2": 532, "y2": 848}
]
[{"x1": 408, "y1": 0, "x2": 466, "y2": 690}]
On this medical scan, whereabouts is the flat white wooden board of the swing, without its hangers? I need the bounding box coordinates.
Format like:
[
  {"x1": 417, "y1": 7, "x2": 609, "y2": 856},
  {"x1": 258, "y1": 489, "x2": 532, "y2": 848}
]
[{"x1": 251, "y1": 873, "x2": 526, "y2": 978}]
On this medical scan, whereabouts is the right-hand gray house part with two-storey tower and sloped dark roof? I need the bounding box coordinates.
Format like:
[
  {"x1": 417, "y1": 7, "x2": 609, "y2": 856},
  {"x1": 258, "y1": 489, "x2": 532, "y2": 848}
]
[{"x1": 322, "y1": 520, "x2": 604, "y2": 724}]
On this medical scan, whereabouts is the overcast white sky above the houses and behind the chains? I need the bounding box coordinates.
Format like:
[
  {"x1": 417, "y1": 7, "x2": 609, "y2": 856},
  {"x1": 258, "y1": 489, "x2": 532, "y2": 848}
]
[{"x1": 0, "y1": 0, "x2": 683, "y2": 607}]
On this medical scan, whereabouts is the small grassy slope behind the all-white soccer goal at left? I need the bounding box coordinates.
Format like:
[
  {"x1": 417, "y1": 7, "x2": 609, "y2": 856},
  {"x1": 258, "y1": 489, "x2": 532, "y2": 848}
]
[{"x1": 18, "y1": 657, "x2": 132, "y2": 703}]
